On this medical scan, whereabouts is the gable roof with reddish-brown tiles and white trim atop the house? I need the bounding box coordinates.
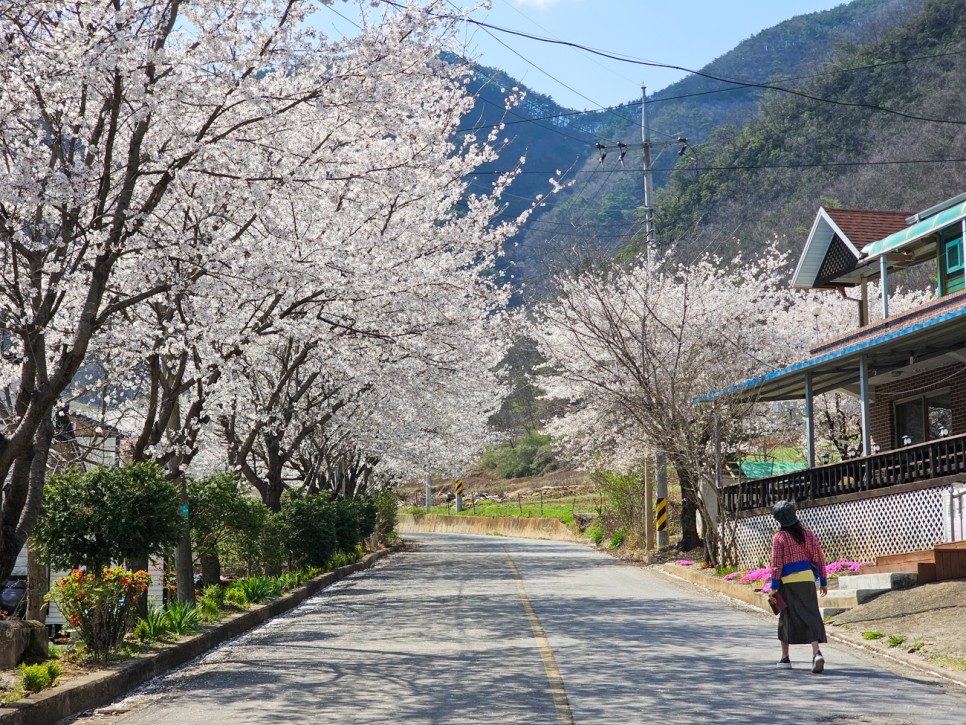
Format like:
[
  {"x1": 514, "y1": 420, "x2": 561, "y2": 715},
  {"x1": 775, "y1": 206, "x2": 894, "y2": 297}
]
[{"x1": 792, "y1": 207, "x2": 909, "y2": 289}]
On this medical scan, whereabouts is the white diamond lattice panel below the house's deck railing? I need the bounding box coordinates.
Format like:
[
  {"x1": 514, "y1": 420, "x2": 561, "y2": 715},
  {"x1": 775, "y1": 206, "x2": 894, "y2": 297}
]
[{"x1": 736, "y1": 486, "x2": 950, "y2": 567}]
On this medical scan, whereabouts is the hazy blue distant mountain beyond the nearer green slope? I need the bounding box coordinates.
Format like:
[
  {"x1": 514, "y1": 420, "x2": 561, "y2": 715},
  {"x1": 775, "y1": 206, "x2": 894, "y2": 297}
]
[{"x1": 458, "y1": 0, "x2": 932, "y2": 291}]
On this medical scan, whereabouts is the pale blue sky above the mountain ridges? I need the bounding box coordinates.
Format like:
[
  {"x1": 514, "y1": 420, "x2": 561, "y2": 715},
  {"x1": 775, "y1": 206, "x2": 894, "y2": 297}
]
[{"x1": 319, "y1": 0, "x2": 846, "y2": 110}]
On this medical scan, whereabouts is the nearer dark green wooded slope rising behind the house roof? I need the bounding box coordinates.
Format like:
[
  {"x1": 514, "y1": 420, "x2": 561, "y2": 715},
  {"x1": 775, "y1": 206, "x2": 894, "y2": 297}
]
[{"x1": 657, "y1": 0, "x2": 966, "y2": 262}]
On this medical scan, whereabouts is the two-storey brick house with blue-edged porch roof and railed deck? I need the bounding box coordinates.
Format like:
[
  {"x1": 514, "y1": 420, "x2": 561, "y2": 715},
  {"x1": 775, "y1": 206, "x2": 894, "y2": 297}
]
[{"x1": 705, "y1": 194, "x2": 966, "y2": 576}]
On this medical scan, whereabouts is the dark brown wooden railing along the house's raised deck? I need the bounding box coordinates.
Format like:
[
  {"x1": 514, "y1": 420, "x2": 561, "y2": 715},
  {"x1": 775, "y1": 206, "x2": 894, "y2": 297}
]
[{"x1": 721, "y1": 435, "x2": 966, "y2": 512}]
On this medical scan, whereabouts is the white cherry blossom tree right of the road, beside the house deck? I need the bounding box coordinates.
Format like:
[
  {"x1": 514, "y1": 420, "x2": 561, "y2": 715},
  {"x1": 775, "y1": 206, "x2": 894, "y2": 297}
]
[{"x1": 531, "y1": 246, "x2": 790, "y2": 550}]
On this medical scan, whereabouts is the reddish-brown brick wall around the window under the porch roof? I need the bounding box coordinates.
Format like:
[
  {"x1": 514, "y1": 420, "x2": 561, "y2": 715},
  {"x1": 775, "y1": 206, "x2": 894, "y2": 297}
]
[{"x1": 869, "y1": 363, "x2": 966, "y2": 451}]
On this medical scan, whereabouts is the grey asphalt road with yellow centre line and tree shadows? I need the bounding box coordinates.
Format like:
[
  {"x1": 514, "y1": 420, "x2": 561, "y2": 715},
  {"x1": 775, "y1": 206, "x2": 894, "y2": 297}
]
[{"x1": 78, "y1": 534, "x2": 966, "y2": 725}]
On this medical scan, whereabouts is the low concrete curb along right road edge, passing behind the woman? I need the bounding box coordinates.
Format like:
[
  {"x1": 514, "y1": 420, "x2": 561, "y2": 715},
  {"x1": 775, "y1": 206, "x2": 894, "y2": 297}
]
[{"x1": 652, "y1": 564, "x2": 966, "y2": 687}]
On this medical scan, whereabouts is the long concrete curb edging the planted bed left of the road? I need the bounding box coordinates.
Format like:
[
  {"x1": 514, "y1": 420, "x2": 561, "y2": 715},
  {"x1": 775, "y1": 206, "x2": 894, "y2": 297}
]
[{"x1": 0, "y1": 548, "x2": 394, "y2": 725}]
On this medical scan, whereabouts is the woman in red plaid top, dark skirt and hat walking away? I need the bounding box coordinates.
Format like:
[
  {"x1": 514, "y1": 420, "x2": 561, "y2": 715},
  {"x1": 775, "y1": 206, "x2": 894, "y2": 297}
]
[{"x1": 769, "y1": 501, "x2": 828, "y2": 674}]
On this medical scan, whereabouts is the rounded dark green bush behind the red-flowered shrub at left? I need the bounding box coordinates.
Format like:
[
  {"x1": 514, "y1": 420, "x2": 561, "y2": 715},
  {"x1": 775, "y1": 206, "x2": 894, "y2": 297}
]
[{"x1": 33, "y1": 462, "x2": 183, "y2": 572}]
